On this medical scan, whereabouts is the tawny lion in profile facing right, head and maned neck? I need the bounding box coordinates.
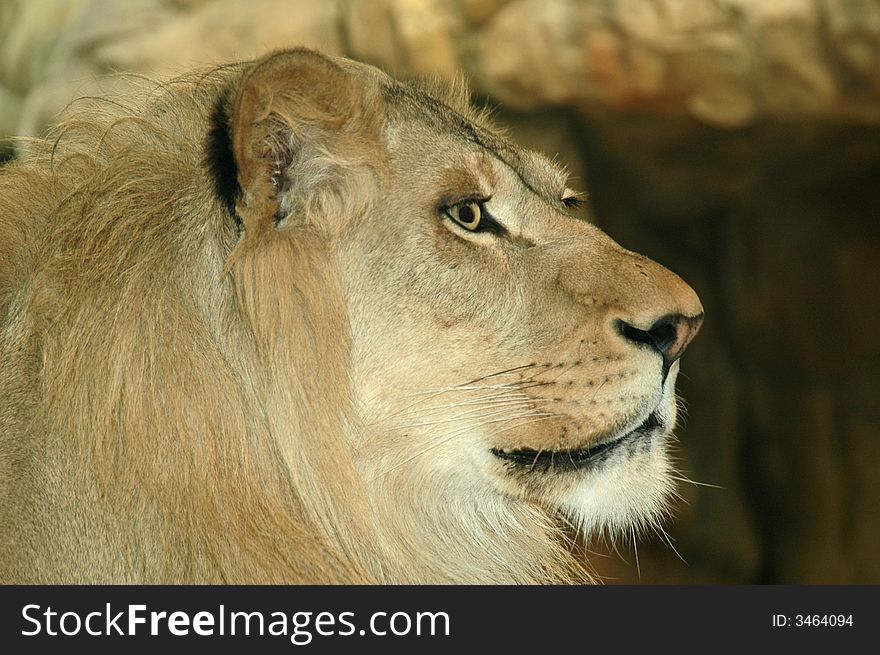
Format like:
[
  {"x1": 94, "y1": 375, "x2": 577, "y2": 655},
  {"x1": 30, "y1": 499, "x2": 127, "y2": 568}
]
[{"x1": 0, "y1": 49, "x2": 703, "y2": 584}]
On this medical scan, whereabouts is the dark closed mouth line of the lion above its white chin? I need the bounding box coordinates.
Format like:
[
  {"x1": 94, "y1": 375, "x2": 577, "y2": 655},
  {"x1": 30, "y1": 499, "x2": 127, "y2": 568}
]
[{"x1": 490, "y1": 411, "x2": 662, "y2": 472}]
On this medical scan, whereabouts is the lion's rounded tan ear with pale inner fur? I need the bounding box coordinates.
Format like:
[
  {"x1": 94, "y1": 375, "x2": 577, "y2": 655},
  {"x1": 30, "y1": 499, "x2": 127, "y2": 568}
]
[{"x1": 230, "y1": 49, "x2": 378, "y2": 234}]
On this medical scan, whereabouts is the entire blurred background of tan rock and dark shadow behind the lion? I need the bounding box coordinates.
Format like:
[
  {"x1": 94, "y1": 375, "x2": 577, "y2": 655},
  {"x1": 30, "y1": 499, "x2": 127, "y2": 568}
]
[{"x1": 0, "y1": 0, "x2": 880, "y2": 584}]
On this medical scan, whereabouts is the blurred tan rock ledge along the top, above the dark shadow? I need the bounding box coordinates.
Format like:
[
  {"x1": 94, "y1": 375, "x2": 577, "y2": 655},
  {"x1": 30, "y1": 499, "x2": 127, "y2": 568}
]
[{"x1": 0, "y1": 0, "x2": 880, "y2": 135}]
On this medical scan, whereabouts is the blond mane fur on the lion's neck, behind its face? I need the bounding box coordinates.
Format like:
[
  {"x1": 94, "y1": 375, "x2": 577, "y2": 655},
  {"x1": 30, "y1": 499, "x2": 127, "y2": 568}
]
[{"x1": 0, "y1": 53, "x2": 700, "y2": 583}]
